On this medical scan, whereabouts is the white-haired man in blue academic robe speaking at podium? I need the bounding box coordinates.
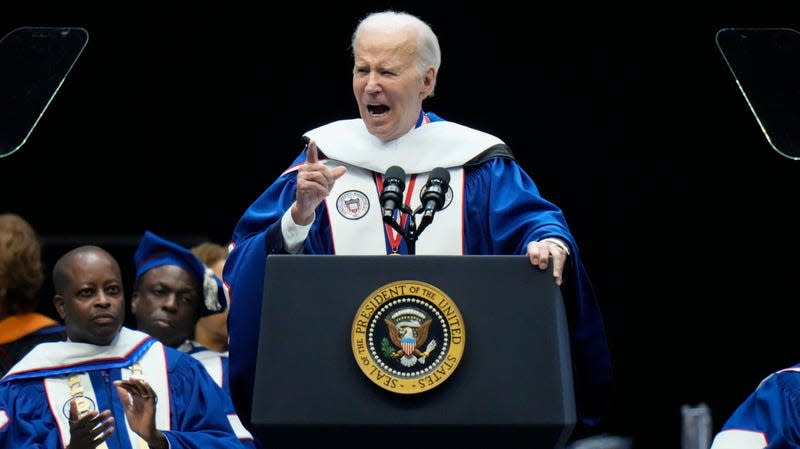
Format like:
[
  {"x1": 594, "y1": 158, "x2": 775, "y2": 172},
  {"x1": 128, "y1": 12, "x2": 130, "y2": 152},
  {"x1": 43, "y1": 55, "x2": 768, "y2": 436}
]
[{"x1": 223, "y1": 11, "x2": 612, "y2": 438}]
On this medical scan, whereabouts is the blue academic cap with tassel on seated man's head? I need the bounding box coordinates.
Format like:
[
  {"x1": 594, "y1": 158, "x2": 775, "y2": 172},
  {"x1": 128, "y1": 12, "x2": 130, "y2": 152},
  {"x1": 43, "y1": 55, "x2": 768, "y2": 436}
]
[{"x1": 133, "y1": 231, "x2": 228, "y2": 316}]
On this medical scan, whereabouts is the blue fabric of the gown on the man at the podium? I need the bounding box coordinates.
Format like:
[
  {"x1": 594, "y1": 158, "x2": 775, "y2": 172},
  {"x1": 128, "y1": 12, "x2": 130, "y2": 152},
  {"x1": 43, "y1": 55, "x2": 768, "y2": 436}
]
[{"x1": 223, "y1": 113, "x2": 612, "y2": 425}]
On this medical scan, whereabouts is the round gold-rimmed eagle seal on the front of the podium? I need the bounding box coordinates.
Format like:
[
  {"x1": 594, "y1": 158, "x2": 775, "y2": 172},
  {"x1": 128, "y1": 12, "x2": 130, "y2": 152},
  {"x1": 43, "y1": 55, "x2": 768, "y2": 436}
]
[{"x1": 350, "y1": 280, "x2": 466, "y2": 394}]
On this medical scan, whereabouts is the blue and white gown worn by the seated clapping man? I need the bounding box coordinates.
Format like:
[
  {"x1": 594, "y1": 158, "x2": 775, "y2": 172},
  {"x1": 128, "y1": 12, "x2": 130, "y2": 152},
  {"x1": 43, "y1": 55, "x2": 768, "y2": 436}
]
[{"x1": 0, "y1": 328, "x2": 255, "y2": 449}]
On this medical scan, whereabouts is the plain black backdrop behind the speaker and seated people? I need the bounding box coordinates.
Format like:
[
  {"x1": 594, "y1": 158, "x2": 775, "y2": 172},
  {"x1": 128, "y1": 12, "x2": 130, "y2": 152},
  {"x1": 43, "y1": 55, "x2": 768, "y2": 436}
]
[{"x1": 0, "y1": 1, "x2": 800, "y2": 448}]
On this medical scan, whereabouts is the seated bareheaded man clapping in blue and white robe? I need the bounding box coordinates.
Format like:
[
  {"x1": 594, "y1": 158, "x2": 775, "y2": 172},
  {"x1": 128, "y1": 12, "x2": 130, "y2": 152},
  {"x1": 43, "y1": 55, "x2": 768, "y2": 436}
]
[{"x1": 0, "y1": 246, "x2": 254, "y2": 449}]
